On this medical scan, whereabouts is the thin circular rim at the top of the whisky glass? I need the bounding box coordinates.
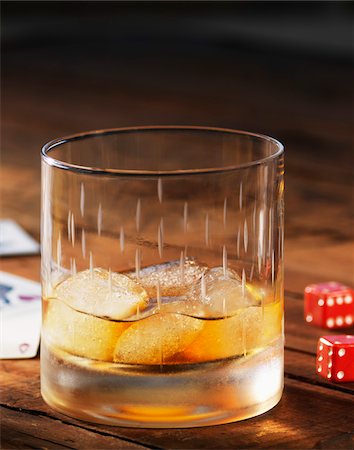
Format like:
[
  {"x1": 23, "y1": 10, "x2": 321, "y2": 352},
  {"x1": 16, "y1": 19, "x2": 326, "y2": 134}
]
[{"x1": 41, "y1": 125, "x2": 284, "y2": 176}]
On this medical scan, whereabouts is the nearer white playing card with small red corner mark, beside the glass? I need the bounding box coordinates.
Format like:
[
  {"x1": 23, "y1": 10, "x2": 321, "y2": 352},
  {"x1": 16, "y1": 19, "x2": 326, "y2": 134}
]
[{"x1": 0, "y1": 271, "x2": 42, "y2": 359}]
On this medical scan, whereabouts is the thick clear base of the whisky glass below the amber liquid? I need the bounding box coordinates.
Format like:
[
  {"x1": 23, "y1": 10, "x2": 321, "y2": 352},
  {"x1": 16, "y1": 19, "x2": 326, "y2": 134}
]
[{"x1": 41, "y1": 339, "x2": 284, "y2": 428}]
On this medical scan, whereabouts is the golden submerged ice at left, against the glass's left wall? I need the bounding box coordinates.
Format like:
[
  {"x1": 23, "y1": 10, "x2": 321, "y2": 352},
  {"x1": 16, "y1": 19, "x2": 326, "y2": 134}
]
[{"x1": 42, "y1": 299, "x2": 129, "y2": 361}]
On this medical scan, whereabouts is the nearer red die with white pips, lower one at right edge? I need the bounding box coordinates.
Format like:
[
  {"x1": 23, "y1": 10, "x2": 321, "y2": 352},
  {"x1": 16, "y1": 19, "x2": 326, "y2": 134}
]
[{"x1": 316, "y1": 335, "x2": 354, "y2": 382}]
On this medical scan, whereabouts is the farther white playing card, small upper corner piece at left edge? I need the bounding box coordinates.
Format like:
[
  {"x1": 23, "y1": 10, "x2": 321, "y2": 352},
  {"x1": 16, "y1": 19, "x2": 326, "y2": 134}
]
[{"x1": 0, "y1": 219, "x2": 39, "y2": 256}]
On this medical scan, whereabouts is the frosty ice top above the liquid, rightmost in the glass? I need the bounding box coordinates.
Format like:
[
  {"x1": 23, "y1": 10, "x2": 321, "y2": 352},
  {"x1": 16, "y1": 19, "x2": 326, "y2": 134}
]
[{"x1": 186, "y1": 267, "x2": 259, "y2": 317}]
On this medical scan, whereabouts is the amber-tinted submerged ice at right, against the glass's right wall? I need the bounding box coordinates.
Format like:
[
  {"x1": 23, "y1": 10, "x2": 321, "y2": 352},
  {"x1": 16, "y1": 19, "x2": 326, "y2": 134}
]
[{"x1": 178, "y1": 302, "x2": 282, "y2": 362}]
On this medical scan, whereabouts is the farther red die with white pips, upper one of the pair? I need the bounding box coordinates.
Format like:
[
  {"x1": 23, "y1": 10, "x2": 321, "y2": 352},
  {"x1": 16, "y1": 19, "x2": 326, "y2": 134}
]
[{"x1": 305, "y1": 281, "x2": 354, "y2": 328}]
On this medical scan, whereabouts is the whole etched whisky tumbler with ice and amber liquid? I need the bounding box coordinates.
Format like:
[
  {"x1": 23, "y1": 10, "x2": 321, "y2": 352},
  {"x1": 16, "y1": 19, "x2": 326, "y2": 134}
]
[{"x1": 41, "y1": 126, "x2": 284, "y2": 427}]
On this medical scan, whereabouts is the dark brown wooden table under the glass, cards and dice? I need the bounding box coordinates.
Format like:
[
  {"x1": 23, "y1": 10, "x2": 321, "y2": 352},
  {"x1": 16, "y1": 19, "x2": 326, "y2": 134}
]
[{"x1": 0, "y1": 23, "x2": 354, "y2": 449}]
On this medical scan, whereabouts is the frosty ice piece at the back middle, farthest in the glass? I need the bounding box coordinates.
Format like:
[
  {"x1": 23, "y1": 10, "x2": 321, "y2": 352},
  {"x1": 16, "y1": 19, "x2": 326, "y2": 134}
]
[{"x1": 128, "y1": 258, "x2": 206, "y2": 298}]
